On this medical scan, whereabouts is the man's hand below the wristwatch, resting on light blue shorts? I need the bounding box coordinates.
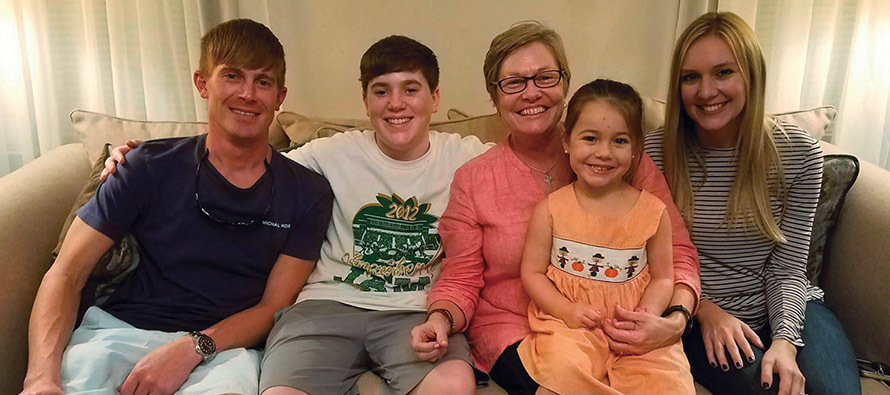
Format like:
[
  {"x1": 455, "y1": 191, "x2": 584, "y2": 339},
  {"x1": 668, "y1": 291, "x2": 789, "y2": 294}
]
[{"x1": 118, "y1": 336, "x2": 202, "y2": 395}]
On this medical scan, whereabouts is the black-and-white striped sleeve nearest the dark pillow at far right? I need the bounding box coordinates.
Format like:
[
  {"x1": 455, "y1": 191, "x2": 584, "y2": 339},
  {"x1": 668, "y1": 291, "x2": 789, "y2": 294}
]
[{"x1": 765, "y1": 141, "x2": 822, "y2": 347}]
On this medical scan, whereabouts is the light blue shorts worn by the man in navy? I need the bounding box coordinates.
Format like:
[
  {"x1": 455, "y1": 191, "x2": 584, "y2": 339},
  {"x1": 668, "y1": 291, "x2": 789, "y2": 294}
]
[{"x1": 62, "y1": 306, "x2": 261, "y2": 395}]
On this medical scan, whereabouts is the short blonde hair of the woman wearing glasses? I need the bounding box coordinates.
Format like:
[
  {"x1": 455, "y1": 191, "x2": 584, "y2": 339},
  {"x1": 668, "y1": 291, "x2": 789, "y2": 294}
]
[{"x1": 482, "y1": 21, "x2": 572, "y2": 105}]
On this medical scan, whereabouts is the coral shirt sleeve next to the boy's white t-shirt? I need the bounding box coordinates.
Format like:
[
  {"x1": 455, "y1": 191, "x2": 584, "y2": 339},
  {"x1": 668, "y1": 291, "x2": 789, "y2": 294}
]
[{"x1": 427, "y1": 164, "x2": 485, "y2": 331}]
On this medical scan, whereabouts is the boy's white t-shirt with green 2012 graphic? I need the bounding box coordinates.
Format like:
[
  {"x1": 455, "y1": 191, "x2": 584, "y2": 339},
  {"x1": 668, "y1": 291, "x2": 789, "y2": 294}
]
[{"x1": 287, "y1": 130, "x2": 489, "y2": 311}]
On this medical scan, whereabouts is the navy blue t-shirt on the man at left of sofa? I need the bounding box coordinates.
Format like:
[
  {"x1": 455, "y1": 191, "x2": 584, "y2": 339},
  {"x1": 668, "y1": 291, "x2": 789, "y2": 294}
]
[{"x1": 77, "y1": 135, "x2": 333, "y2": 331}]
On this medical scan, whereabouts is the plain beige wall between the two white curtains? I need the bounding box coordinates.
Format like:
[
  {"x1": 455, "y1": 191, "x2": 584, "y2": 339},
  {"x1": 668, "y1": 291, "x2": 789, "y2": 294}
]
[{"x1": 258, "y1": 0, "x2": 706, "y2": 120}]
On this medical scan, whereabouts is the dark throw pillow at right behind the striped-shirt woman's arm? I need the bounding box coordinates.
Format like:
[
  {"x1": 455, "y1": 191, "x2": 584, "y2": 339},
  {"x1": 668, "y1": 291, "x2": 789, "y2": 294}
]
[{"x1": 807, "y1": 154, "x2": 859, "y2": 286}]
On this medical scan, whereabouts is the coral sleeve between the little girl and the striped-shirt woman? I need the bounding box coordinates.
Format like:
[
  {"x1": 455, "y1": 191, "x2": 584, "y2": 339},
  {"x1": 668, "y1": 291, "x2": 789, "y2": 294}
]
[{"x1": 631, "y1": 154, "x2": 701, "y2": 314}]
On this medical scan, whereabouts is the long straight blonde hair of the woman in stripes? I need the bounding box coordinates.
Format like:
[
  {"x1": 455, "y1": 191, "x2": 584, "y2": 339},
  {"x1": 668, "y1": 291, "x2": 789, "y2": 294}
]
[{"x1": 663, "y1": 12, "x2": 785, "y2": 242}]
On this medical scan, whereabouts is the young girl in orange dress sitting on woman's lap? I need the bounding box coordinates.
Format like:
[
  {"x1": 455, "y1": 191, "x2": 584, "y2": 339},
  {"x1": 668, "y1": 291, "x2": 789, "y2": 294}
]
[{"x1": 518, "y1": 79, "x2": 695, "y2": 394}]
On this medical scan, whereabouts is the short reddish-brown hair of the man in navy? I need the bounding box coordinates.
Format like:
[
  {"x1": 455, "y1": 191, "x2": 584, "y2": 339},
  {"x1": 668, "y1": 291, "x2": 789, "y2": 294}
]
[{"x1": 199, "y1": 19, "x2": 286, "y2": 89}]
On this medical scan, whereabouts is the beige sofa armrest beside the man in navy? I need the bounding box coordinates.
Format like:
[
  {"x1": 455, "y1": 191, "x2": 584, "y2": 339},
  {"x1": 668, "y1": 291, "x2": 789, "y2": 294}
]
[{"x1": 0, "y1": 144, "x2": 90, "y2": 394}]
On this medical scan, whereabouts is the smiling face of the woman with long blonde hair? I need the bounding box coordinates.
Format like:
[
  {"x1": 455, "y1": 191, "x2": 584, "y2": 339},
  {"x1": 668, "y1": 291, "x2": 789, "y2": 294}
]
[{"x1": 680, "y1": 35, "x2": 747, "y2": 148}]
